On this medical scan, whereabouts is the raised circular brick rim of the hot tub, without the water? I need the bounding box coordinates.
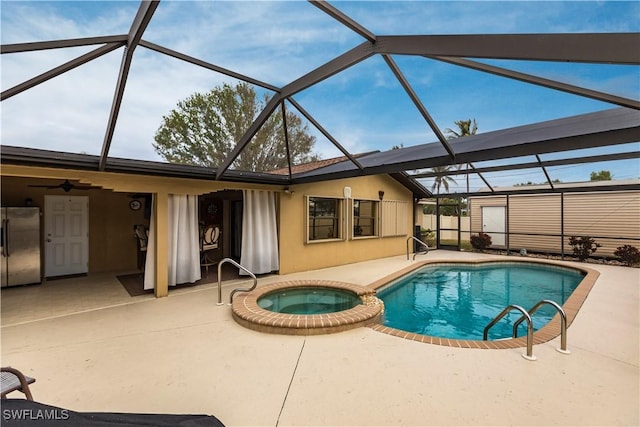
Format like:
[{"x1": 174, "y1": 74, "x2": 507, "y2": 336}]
[{"x1": 232, "y1": 280, "x2": 383, "y2": 335}]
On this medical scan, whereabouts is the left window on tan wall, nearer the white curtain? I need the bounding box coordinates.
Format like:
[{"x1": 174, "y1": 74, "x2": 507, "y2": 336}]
[{"x1": 307, "y1": 197, "x2": 342, "y2": 241}]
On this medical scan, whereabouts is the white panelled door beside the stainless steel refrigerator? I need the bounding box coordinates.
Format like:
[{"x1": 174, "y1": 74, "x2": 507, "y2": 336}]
[{"x1": 44, "y1": 196, "x2": 89, "y2": 277}]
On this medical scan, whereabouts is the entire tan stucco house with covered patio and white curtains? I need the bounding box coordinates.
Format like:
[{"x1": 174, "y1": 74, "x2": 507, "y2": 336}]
[{"x1": 1, "y1": 147, "x2": 428, "y2": 296}]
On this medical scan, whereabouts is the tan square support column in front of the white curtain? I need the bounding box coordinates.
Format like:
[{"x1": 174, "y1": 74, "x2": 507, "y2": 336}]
[{"x1": 153, "y1": 193, "x2": 169, "y2": 298}]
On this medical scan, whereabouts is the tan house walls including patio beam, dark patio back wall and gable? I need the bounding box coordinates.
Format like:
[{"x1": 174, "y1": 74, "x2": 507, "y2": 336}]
[{"x1": 2, "y1": 165, "x2": 414, "y2": 284}]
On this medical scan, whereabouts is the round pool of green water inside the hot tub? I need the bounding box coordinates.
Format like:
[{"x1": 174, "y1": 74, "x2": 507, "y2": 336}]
[{"x1": 258, "y1": 287, "x2": 362, "y2": 314}]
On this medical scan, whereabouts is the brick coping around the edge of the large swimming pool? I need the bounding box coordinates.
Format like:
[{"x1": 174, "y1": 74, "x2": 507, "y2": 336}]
[{"x1": 368, "y1": 258, "x2": 600, "y2": 349}]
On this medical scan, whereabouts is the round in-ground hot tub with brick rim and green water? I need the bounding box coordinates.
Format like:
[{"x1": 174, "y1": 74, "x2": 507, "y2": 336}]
[{"x1": 232, "y1": 280, "x2": 383, "y2": 335}]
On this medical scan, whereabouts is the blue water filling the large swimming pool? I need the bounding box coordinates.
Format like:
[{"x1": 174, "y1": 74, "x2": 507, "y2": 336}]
[{"x1": 377, "y1": 262, "x2": 584, "y2": 340}]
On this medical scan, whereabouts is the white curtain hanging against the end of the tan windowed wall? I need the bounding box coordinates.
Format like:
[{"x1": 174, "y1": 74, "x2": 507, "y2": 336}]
[{"x1": 240, "y1": 190, "x2": 280, "y2": 274}]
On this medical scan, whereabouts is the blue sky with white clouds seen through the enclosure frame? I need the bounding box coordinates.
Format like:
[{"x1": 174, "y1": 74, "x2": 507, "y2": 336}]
[{"x1": 0, "y1": 0, "x2": 640, "y2": 188}]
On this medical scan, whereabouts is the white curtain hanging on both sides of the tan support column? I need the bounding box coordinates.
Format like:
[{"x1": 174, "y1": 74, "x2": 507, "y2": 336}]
[{"x1": 144, "y1": 194, "x2": 201, "y2": 289}]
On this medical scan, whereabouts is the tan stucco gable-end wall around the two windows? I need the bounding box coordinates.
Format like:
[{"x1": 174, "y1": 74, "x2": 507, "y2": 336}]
[{"x1": 279, "y1": 175, "x2": 414, "y2": 274}]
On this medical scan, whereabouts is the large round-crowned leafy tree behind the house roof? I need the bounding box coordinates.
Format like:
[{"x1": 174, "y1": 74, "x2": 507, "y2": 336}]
[{"x1": 153, "y1": 83, "x2": 318, "y2": 171}]
